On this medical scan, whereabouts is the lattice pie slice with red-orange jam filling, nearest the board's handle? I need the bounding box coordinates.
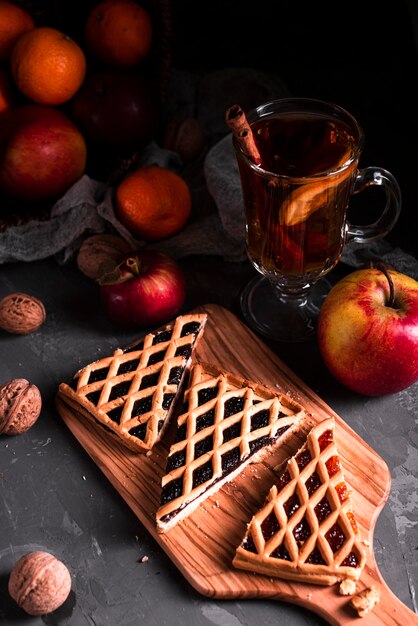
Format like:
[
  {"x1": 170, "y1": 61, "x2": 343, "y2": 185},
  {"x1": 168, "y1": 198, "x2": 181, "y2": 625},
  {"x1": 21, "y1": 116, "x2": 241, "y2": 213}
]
[{"x1": 233, "y1": 417, "x2": 366, "y2": 585}]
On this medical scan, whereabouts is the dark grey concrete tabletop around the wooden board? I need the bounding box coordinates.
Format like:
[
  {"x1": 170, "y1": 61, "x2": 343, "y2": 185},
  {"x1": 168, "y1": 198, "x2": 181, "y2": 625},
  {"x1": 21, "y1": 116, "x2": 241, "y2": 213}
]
[{"x1": 0, "y1": 258, "x2": 418, "y2": 626}]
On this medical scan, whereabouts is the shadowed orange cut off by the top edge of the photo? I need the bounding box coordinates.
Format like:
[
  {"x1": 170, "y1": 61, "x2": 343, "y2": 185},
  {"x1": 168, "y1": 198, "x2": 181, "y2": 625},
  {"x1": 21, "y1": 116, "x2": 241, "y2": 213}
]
[{"x1": 84, "y1": 0, "x2": 153, "y2": 67}]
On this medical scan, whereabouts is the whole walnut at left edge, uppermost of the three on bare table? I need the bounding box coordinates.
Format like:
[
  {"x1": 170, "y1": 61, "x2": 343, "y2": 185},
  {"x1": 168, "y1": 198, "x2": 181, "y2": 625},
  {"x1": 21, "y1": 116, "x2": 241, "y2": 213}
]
[{"x1": 0, "y1": 293, "x2": 46, "y2": 335}]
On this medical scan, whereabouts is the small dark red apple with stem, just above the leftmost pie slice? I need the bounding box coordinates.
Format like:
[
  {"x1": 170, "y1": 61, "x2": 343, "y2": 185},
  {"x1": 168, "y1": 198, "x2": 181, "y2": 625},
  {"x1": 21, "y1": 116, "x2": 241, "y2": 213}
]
[{"x1": 99, "y1": 250, "x2": 186, "y2": 327}]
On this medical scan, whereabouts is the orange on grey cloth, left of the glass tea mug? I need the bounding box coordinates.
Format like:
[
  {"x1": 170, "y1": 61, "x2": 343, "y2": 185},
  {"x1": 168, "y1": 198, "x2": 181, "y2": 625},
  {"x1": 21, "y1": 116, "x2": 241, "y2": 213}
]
[{"x1": 115, "y1": 165, "x2": 192, "y2": 241}]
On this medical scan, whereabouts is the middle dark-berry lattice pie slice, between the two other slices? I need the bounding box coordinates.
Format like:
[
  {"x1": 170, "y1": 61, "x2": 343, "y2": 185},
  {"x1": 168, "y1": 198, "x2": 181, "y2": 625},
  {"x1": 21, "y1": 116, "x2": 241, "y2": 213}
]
[{"x1": 156, "y1": 363, "x2": 305, "y2": 532}]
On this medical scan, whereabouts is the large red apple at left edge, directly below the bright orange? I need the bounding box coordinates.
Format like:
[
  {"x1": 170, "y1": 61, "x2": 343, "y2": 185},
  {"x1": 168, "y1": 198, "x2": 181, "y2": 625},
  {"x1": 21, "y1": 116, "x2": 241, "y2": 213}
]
[{"x1": 0, "y1": 104, "x2": 87, "y2": 203}]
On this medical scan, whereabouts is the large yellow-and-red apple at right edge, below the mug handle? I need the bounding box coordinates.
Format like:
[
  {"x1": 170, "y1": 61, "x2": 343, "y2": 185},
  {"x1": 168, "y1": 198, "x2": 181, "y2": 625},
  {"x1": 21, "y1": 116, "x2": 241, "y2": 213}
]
[{"x1": 318, "y1": 268, "x2": 418, "y2": 396}]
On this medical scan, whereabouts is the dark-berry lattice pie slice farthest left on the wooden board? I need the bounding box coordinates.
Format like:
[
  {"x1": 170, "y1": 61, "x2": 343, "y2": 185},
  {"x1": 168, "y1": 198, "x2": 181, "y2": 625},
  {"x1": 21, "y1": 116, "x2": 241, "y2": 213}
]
[{"x1": 58, "y1": 314, "x2": 207, "y2": 453}]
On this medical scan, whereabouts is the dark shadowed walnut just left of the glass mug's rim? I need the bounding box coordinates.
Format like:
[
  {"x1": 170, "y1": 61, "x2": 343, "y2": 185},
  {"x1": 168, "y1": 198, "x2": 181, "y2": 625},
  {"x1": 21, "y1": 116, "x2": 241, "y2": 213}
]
[{"x1": 162, "y1": 115, "x2": 205, "y2": 163}]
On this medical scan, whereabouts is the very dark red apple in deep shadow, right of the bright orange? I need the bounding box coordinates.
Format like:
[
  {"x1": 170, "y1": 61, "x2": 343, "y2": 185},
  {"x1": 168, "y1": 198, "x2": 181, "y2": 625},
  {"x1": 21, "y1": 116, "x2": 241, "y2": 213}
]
[{"x1": 71, "y1": 68, "x2": 160, "y2": 149}]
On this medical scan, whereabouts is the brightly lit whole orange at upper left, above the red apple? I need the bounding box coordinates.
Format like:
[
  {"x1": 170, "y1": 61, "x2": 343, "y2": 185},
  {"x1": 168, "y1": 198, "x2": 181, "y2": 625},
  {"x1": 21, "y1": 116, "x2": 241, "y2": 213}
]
[{"x1": 10, "y1": 26, "x2": 86, "y2": 106}]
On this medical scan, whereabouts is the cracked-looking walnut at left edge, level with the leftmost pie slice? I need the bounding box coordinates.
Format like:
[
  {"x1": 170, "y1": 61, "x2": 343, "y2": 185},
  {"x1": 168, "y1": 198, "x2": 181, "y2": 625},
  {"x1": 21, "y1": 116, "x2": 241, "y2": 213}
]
[{"x1": 0, "y1": 378, "x2": 42, "y2": 435}]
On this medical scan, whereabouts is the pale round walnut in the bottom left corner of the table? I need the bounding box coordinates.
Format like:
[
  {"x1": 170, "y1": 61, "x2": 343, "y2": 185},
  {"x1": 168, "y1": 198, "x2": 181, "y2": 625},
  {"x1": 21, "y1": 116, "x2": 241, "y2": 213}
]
[{"x1": 8, "y1": 551, "x2": 71, "y2": 615}]
